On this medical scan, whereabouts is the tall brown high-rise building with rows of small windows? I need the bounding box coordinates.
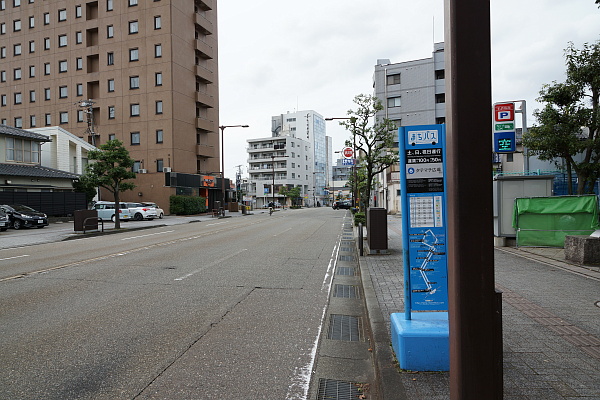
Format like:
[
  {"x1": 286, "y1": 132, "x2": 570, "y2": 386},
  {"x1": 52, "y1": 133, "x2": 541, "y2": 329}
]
[{"x1": 0, "y1": 0, "x2": 220, "y2": 208}]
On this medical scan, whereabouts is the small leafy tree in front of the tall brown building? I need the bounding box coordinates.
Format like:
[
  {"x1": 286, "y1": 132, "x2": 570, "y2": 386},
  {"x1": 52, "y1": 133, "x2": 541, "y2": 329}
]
[{"x1": 85, "y1": 140, "x2": 136, "y2": 229}]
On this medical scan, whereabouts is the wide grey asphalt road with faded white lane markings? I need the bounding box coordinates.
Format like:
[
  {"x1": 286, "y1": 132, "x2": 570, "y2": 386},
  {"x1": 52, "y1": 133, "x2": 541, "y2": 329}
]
[{"x1": 0, "y1": 208, "x2": 348, "y2": 400}]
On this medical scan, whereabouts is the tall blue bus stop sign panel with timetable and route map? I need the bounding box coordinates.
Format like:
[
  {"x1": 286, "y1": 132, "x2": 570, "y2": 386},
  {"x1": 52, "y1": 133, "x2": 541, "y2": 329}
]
[{"x1": 398, "y1": 125, "x2": 448, "y2": 316}]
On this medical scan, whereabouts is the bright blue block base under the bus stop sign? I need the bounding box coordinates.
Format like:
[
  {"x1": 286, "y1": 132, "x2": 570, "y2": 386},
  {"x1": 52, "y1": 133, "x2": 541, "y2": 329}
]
[{"x1": 391, "y1": 312, "x2": 450, "y2": 371}]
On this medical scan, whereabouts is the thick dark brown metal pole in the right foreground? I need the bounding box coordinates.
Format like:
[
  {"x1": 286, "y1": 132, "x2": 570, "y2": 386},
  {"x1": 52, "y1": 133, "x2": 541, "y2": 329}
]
[{"x1": 445, "y1": 0, "x2": 502, "y2": 400}]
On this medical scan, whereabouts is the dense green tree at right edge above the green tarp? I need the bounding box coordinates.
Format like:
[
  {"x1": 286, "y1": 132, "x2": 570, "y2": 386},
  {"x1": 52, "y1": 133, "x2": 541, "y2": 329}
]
[{"x1": 523, "y1": 41, "x2": 600, "y2": 194}]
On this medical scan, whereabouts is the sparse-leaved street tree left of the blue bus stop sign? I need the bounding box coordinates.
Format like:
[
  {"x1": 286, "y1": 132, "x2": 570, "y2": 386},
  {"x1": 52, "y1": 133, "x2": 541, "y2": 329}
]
[{"x1": 340, "y1": 94, "x2": 398, "y2": 211}]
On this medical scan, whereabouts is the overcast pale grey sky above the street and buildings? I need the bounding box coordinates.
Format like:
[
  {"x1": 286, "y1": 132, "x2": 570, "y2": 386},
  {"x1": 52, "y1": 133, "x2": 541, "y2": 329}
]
[{"x1": 218, "y1": 0, "x2": 600, "y2": 178}]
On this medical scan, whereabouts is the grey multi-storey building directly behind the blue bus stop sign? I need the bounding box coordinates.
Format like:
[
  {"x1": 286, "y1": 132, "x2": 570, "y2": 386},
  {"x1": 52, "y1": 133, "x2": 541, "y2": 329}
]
[{"x1": 370, "y1": 43, "x2": 446, "y2": 213}]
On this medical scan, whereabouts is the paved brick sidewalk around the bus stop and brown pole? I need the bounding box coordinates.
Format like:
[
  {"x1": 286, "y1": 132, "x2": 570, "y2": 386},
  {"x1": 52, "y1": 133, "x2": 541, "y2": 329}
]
[{"x1": 359, "y1": 215, "x2": 600, "y2": 400}]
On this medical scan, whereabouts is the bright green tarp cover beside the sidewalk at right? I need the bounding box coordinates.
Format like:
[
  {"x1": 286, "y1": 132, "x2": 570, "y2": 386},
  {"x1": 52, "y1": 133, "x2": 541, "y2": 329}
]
[{"x1": 513, "y1": 195, "x2": 599, "y2": 247}]
